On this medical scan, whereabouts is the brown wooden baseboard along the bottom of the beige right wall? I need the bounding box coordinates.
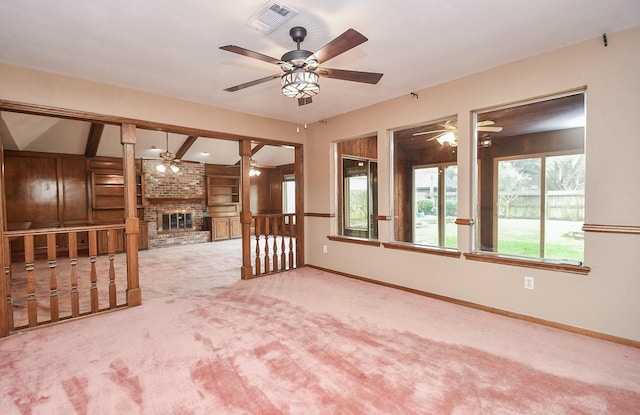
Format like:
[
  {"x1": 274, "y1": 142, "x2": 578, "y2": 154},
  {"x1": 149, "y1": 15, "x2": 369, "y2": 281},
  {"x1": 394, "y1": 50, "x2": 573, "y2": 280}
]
[{"x1": 305, "y1": 264, "x2": 640, "y2": 349}]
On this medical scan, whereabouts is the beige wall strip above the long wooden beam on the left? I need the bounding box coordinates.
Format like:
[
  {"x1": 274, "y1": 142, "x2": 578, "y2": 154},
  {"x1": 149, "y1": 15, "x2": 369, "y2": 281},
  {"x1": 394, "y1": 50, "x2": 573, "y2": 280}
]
[{"x1": 0, "y1": 63, "x2": 306, "y2": 143}]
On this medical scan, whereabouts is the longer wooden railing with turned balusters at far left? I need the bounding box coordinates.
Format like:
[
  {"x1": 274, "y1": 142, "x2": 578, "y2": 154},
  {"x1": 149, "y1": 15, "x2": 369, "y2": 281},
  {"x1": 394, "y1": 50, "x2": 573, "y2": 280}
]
[{"x1": 3, "y1": 224, "x2": 127, "y2": 331}]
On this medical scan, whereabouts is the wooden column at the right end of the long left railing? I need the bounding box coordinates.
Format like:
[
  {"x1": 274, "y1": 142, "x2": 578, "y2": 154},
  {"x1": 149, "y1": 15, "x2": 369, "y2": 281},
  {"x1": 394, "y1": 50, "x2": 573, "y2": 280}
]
[{"x1": 121, "y1": 124, "x2": 142, "y2": 307}]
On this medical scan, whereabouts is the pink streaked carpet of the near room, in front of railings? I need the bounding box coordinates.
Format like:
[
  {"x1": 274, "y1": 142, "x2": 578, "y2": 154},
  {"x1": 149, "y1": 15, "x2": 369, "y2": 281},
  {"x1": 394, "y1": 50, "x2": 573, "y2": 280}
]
[{"x1": 0, "y1": 268, "x2": 640, "y2": 415}]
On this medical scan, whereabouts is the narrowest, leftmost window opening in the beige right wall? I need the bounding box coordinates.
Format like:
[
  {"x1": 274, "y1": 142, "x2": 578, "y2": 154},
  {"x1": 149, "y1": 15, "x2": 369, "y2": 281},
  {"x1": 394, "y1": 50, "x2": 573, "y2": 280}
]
[{"x1": 336, "y1": 136, "x2": 378, "y2": 239}]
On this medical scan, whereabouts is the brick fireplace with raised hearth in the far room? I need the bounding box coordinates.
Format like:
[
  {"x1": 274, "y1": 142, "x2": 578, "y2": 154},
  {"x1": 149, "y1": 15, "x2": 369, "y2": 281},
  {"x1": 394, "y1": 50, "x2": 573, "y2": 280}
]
[{"x1": 142, "y1": 160, "x2": 210, "y2": 248}]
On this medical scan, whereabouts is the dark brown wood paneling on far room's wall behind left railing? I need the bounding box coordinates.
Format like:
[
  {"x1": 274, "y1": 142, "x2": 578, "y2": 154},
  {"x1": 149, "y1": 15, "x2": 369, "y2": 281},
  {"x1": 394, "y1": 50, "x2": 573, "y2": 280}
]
[{"x1": 5, "y1": 151, "x2": 148, "y2": 253}]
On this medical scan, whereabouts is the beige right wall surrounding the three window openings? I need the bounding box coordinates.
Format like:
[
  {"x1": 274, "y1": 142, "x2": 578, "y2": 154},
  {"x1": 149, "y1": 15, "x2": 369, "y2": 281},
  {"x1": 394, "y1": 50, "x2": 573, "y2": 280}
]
[{"x1": 305, "y1": 28, "x2": 640, "y2": 341}]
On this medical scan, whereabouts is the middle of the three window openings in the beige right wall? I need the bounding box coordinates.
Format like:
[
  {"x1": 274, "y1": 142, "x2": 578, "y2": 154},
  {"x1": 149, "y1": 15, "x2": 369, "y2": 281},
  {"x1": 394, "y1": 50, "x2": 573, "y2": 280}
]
[{"x1": 393, "y1": 118, "x2": 458, "y2": 248}]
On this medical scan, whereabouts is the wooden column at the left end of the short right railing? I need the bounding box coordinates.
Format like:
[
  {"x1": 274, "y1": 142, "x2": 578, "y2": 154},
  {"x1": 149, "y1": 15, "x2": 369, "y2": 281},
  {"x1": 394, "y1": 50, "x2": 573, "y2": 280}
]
[{"x1": 239, "y1": 140, "x2": 253, "y2": 280}]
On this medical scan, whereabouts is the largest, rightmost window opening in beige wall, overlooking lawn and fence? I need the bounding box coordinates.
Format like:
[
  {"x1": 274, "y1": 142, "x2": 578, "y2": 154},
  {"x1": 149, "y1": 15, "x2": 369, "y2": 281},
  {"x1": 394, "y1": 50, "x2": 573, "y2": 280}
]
[{"x1": 477, "y1": 93, "x2": 585, "y2": 263}]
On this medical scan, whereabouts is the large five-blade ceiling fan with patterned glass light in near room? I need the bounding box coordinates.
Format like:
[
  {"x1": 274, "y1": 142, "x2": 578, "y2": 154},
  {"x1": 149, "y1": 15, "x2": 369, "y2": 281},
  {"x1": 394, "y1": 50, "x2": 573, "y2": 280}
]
[{"x1": 220, "y1": 26, "x2": 383, "y2": 105}]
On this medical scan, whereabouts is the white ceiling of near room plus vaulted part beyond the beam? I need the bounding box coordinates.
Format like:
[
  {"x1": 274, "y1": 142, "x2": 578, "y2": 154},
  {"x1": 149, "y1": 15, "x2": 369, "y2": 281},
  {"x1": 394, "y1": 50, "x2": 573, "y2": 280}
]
[{"x1": 0, "y1": 0, "x2": 640, "y2": 165}]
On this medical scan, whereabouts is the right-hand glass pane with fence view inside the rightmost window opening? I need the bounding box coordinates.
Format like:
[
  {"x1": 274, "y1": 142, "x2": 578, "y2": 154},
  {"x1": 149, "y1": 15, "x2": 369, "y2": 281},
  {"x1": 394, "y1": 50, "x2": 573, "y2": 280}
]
[{"x1": 544, "y1": 154, "x2": 585, "y2": 262}]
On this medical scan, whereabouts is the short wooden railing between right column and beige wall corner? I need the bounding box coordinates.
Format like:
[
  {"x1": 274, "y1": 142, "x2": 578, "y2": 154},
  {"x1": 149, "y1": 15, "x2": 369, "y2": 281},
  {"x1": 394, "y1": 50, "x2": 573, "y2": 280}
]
[{"x1": 252, "y1": 213, "x2": 298, "y2": 276}]
